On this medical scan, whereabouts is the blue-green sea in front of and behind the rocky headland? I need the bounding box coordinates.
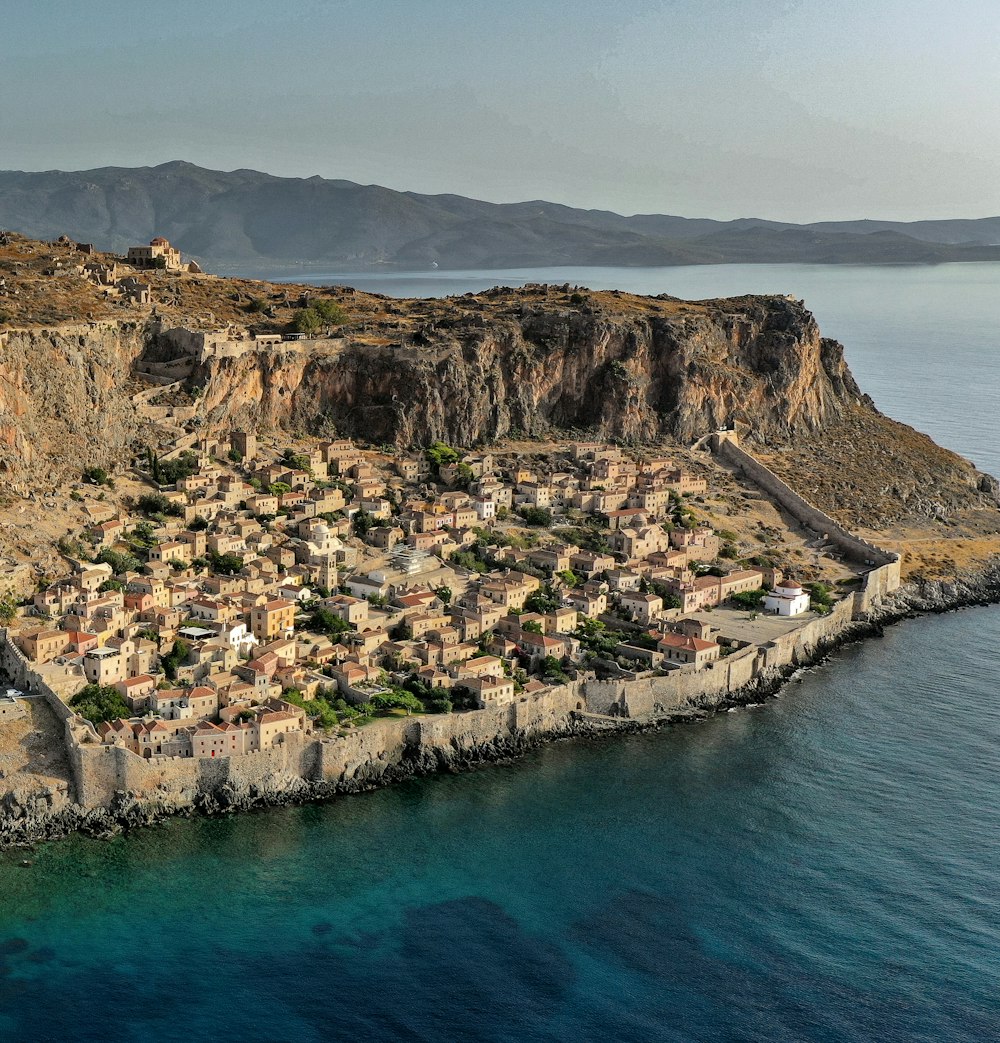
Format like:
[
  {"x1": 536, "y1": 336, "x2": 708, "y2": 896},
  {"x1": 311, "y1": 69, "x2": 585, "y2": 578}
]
[{"x1": 0, "y1": 264, "x2": 1000, "y2": 1043}]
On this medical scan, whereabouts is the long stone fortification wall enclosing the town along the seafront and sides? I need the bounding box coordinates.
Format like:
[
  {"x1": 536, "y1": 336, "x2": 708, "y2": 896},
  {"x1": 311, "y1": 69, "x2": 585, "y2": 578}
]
[{"x1": 0, "y1": 433, "x2": 900, "y2": 809}]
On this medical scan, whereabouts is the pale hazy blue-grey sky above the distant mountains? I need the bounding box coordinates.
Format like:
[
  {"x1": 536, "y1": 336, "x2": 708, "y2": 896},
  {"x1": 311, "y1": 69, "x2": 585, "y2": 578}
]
[{"x1": 0, "y1": 0, "x2": 1000, "y2": 220}]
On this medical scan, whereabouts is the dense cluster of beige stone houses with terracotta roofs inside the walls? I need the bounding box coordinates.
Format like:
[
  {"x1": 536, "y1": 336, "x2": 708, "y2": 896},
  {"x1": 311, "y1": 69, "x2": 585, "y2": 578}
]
[{"x1": 9, "y1": 432, "x2": 809, "y2": 757}]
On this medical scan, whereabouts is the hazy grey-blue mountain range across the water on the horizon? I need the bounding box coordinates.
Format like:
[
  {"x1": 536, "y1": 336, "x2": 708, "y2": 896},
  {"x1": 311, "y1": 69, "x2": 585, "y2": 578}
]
[{"x1": 0, "y1": 162, "x2": 1000, "y2": 271}]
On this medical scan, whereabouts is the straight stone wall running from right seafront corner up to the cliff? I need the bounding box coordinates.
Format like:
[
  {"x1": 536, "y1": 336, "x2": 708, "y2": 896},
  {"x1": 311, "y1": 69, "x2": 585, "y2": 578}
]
[{"x1": 711, "y1": 431, "x2": 900, "y2": 620}]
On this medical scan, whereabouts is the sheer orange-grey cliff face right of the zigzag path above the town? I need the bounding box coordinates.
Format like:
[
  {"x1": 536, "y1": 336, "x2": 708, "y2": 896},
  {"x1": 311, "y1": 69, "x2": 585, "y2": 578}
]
[{"x1": 198, "y1": 297, "x2": 861, "y2": 445}]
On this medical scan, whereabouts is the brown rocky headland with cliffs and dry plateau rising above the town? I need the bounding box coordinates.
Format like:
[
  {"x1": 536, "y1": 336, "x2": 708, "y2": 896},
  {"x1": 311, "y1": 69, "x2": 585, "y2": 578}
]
[{"x1": 0, "y1": 237, "x2": 995, "y2": 528}]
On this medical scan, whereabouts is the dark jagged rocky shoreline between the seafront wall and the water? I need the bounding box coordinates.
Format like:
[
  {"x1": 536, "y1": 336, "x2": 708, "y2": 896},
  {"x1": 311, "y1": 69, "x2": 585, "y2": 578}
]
[{"x1": 0, "y1": 560, "x2": 1000, "y2": 848}]
